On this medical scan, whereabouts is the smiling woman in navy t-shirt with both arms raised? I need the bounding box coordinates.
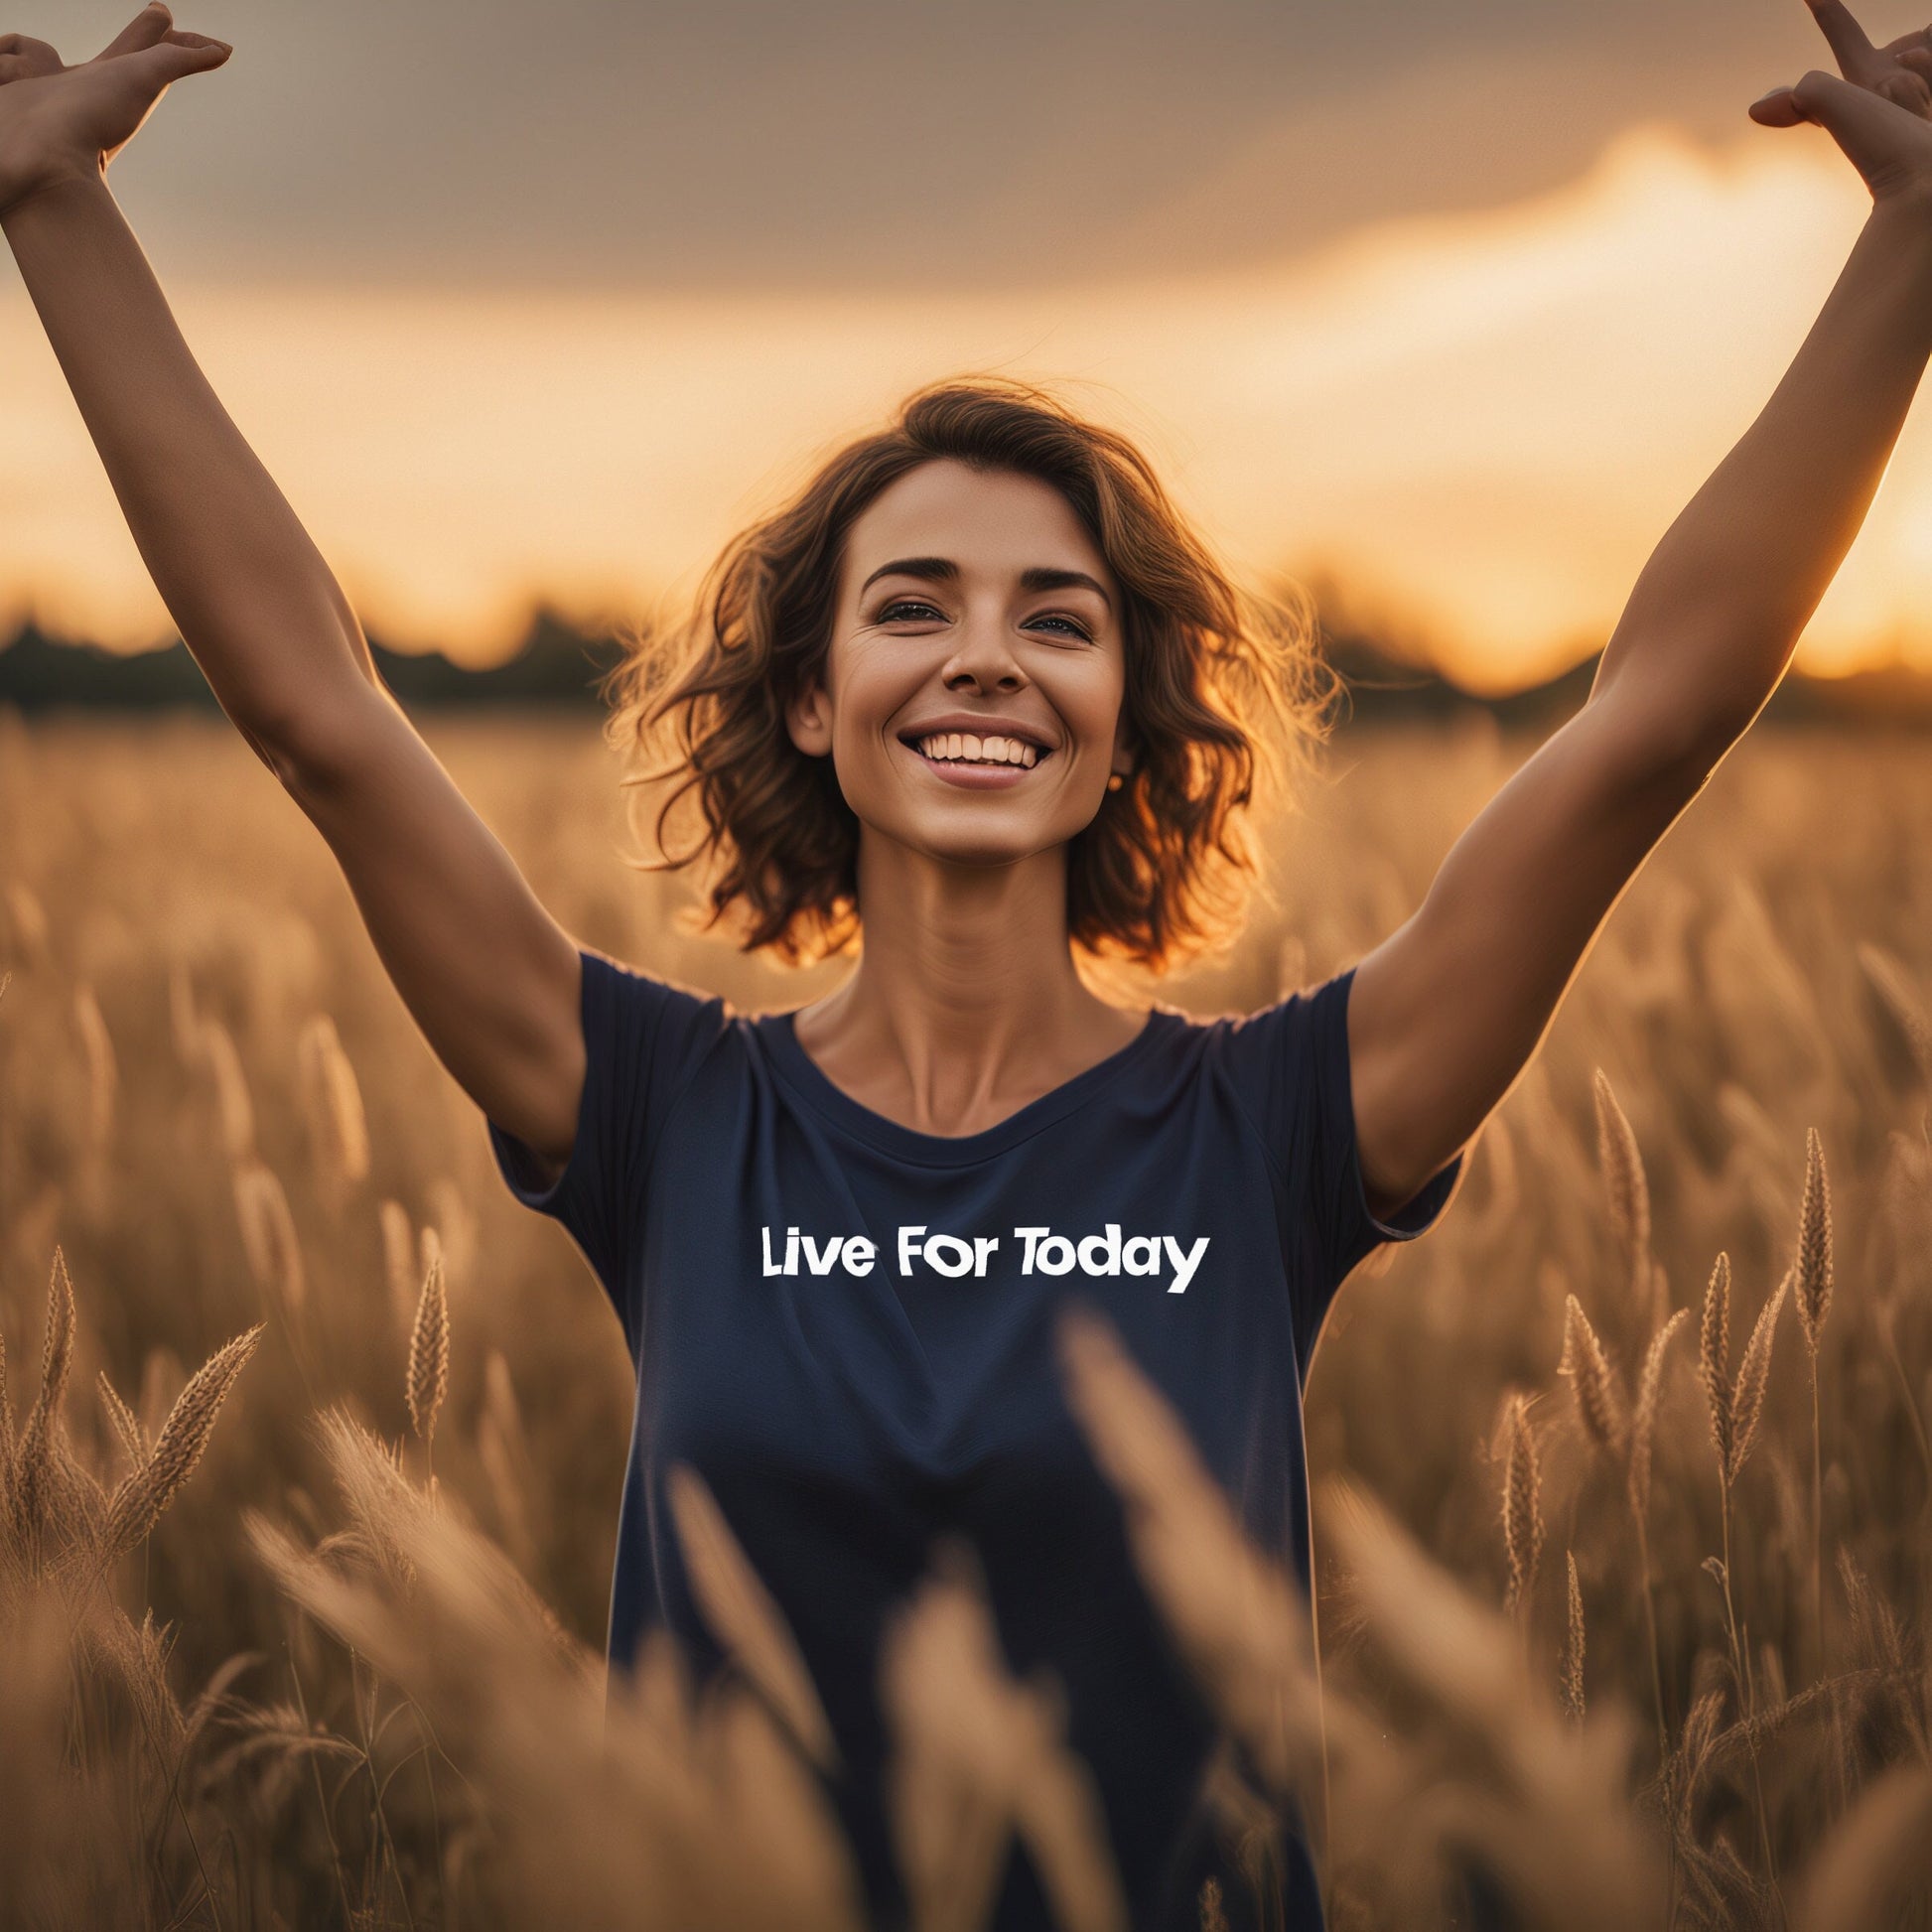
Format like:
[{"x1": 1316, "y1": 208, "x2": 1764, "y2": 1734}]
[{"x1": 11, "y1": 0, "x2": 1932, "y2": 1932}]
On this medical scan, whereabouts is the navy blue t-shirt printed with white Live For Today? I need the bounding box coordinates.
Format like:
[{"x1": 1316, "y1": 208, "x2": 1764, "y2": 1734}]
[{"x1": 488, "y1": 948, "x2": 1462, "y2": 1932}]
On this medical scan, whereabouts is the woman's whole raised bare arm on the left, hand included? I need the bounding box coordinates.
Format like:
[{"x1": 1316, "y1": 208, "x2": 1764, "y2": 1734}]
[{"x1": 0, "y1": 6, "x2": 584, "y2": 1165}]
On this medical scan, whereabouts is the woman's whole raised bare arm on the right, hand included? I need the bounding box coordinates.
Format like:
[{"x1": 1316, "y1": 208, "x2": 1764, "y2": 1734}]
[{"x1": 1348, "y1": 0, "x2": 1932, "y2": 1211}]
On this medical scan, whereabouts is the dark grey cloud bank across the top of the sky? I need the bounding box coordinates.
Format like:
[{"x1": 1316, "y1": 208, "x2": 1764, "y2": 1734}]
[{"x1": 0, "y1": 0, "x2": 1822, "y2": 292}]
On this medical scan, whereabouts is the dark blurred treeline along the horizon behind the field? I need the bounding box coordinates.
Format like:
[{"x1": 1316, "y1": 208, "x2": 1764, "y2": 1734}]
[{"x1": 0, "y1": 609, "x2": 1932, "y2": 731}]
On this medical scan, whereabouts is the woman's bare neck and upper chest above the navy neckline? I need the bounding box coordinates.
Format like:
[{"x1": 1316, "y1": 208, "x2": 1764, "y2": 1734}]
[{"x1": 796, "y1": 839, "x2": 1146, "y2": 1134}]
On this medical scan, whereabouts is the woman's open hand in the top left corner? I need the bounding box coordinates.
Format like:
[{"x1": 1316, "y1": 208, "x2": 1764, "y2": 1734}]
[{"x1": 0, "y1": 0, "x2": 232, "y2": 214}]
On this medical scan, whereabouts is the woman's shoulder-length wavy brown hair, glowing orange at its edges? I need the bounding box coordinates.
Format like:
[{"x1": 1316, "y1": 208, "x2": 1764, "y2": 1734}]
[{"x1": 603, "y1": 376, "x2": 1339, "y2": 972}]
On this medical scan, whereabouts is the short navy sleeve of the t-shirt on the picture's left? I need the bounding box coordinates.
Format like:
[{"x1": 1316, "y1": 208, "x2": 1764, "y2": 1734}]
[{"x1": 486, "y1": 947, "x2": 729, "y2": 1350}]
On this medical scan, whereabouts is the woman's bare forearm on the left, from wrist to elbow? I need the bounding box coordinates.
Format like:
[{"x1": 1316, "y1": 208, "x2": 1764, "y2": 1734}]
[{"x1": 0, "y1": 176, "x2": 376, "y2": 750}]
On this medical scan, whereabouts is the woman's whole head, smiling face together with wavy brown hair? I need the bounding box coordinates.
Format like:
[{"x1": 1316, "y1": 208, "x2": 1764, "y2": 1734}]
[{"x1": 611, "y1": 376, "x2": 1337, "y2": 970}]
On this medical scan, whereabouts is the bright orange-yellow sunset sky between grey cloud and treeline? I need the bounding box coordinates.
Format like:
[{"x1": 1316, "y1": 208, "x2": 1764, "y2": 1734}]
[{"x1": 0, "y1": 127, "x2": 1932, "y2": 690}]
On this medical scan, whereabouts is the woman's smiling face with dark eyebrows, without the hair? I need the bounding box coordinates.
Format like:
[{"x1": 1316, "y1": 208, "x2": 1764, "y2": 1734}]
[{"x1": 788, "y1": 460, "x2": 1130, "y2": 866}]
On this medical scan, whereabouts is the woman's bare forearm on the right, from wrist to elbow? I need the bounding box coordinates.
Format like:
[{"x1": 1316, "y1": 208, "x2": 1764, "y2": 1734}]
[{"x1": 1595, "y1": 199, "x2": 1932, "y2": 752}]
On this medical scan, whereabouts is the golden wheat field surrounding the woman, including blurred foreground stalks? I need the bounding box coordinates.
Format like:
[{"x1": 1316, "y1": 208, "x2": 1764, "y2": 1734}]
[{"x1": 0, "y1": 713, "x2": 1932, "y2": 1932}]
